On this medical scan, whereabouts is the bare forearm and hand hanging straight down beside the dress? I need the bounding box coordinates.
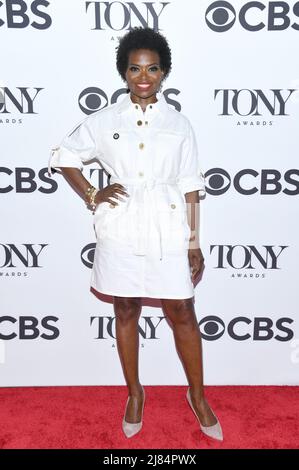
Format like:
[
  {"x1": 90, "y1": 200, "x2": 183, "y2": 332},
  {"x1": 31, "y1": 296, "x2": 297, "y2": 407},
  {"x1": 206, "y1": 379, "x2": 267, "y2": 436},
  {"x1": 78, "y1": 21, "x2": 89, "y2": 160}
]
[{"x1": 185, "y1": 191, "x2": 204, "y2": 282}]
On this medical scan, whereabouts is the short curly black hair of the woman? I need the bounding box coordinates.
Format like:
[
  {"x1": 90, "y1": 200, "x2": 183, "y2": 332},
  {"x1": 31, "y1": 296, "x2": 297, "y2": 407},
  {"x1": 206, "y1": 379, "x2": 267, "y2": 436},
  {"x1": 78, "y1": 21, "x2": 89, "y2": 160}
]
[{"x1": 116, "y1": 26, "x2": 171, "y2": 81}]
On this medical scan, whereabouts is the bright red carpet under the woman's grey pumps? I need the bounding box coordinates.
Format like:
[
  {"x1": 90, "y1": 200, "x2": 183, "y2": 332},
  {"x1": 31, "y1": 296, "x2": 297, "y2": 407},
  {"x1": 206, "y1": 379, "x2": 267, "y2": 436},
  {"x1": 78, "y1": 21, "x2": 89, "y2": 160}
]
[{"x1": 0, "y1": 386, "x2": 299, "y2": 449}]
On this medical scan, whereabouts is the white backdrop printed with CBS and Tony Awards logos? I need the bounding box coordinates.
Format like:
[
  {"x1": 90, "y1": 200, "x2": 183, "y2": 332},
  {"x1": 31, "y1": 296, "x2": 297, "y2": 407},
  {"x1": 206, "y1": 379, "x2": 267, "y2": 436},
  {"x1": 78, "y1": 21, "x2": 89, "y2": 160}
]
[{"x1": 0, "y1": 0, "x2": 299, "y2": 386}]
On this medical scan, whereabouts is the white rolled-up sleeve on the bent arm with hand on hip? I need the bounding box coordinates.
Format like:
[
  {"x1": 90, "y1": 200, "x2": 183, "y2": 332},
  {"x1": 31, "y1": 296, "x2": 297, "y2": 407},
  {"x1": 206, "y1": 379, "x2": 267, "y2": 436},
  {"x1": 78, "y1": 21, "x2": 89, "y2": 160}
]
[{"x1": 48, "y1": 119, "x2": 97, "y2": 175}]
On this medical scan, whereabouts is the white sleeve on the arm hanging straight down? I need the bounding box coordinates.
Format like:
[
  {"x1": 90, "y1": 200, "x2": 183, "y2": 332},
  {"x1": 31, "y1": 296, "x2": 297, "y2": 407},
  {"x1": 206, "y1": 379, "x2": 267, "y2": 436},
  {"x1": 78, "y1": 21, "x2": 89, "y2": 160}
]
[{"x1": 177, "y1": 122, "x2": 206, "y2": 196}]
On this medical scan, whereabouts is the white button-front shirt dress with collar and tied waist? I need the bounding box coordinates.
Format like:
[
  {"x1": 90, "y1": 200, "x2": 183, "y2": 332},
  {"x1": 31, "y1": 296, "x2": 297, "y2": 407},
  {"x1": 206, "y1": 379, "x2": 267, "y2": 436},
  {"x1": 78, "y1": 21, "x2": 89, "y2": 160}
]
[{"x1": 49, "y1": 93, "x2": 205, "y2": 299}]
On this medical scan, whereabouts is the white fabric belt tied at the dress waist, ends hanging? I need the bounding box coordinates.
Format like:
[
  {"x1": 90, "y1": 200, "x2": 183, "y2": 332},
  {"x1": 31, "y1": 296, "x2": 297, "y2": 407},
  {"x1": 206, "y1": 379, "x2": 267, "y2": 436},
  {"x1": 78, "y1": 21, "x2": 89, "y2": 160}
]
[{"x1": 110, "y1": 176, "x2": 177, "y2": 260}]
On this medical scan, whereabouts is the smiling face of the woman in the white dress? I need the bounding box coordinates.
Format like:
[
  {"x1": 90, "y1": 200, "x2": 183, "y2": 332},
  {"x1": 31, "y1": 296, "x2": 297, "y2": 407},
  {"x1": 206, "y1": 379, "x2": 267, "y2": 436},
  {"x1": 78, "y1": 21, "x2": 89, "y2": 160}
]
[{"x1": 126, "y1": 49, "x2": 163, "y2": 99}]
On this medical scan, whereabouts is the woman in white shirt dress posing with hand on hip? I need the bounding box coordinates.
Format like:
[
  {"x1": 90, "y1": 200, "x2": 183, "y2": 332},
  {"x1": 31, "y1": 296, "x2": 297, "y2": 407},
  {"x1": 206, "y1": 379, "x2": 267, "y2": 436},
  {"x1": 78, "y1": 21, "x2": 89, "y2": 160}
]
[{"x1": 49, "y1": 28, "x2": 223, "y2": 440}]
